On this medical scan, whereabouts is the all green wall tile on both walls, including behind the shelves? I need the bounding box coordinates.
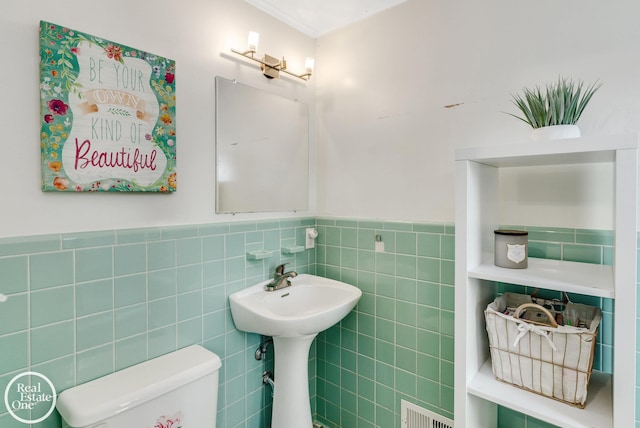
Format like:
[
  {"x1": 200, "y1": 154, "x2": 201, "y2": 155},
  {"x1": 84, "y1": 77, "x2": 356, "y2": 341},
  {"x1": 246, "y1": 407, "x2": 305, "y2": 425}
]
[{"x1": 0, "y1": 221, "x2": 640, "y2": 428}]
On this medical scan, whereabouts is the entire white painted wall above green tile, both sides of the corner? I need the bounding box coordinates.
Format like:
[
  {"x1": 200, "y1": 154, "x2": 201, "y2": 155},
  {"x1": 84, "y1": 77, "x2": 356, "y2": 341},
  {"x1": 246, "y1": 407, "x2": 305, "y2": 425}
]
[{"x1": 5, "y1": 0, "x2": 640, "y2": 237}]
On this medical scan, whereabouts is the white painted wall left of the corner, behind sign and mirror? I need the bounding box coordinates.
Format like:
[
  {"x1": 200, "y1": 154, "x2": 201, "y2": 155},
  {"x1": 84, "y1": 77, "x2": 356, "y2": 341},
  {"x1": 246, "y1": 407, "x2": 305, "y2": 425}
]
[{"x1": 0, "y1": 0, "x2": 315, "y2": 237}]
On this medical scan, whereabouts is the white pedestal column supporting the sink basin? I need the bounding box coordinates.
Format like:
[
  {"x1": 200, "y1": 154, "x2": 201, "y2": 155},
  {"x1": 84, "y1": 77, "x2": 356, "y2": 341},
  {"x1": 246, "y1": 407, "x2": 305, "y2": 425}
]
[{"x1": 271, "y1": 334, "x2": 316, "y2": 428}]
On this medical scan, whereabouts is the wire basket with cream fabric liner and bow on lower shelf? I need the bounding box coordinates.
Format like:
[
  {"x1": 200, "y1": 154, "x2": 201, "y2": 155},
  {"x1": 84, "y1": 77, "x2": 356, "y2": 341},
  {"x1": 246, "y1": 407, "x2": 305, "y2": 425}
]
[{"x1": 484, "y1": 293, "x2": 602, "y2": 408}]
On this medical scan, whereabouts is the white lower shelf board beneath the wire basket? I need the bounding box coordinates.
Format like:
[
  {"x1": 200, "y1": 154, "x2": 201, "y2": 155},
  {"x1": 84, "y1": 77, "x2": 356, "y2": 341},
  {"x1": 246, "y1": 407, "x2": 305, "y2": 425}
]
[{"x1": 467, "y1": 359, "x2": 613, "y2": 428}]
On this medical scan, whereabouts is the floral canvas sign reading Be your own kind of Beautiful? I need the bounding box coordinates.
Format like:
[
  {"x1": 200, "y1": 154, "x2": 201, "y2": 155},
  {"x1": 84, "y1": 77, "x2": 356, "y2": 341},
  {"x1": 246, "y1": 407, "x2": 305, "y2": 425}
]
[{"x1": 40, "y1": 21, "x2": 176, "y2": 192}]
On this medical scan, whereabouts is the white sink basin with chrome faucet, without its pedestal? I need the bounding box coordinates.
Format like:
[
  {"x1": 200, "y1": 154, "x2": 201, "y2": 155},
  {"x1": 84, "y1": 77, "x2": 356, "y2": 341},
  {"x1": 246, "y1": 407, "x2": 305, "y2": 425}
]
[{"x1": 229, "y1": 274, "x2": 362, "y2": 337}]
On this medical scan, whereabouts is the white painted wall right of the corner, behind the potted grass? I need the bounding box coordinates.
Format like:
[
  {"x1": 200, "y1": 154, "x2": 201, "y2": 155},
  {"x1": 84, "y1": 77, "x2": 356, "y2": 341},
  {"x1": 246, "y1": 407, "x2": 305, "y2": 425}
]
[{"x1": 316, "y1": 0, "x2": 640, "y2": 228}]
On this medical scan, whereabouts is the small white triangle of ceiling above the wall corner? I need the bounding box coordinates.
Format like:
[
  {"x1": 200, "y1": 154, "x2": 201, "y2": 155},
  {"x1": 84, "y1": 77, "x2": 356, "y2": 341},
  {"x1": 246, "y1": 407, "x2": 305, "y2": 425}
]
[{"x1": 245, "y1": 0, "x2": 406, "y2": 38}]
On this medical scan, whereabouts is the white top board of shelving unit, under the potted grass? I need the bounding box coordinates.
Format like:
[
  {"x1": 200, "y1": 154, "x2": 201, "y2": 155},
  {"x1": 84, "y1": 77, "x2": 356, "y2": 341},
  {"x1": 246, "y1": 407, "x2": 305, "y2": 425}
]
[{"x1": 456, "y1": 134, "x2": 638, "y2": 167}]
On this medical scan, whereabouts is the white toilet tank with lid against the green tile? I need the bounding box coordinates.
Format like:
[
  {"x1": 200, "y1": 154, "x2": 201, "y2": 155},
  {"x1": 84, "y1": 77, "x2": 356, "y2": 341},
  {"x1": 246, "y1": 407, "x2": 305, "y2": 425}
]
[{"x1": 56, "y1": 345, "x2": 222, "y2": 428}]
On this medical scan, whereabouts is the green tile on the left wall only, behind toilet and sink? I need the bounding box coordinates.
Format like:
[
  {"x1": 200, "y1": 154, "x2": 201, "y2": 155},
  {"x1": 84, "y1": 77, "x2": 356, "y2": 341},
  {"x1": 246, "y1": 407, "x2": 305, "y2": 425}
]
[{"x1": 0, "y1": 218, "x2": 316, "y2": 428}]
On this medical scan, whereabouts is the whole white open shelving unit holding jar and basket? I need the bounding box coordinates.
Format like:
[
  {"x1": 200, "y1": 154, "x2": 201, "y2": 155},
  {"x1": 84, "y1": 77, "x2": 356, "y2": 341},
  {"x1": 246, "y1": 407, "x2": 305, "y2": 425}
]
[{"x1": 454, "y1": 134, "x2": 638, "y2": 428}]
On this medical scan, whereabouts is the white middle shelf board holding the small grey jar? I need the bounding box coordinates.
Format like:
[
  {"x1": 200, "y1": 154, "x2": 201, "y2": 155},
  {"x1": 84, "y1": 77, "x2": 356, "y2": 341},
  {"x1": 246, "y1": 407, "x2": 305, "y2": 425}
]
[{"x1": 468, "y1": 257, "x2": 615, "y2": 298}]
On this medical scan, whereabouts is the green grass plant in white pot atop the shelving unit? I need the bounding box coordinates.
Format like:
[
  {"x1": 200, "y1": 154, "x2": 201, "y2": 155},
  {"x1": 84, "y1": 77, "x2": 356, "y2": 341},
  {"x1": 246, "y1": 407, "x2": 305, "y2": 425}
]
[{"x1": 507, "y1": 77, "x2": 602, "y2": 141}]
